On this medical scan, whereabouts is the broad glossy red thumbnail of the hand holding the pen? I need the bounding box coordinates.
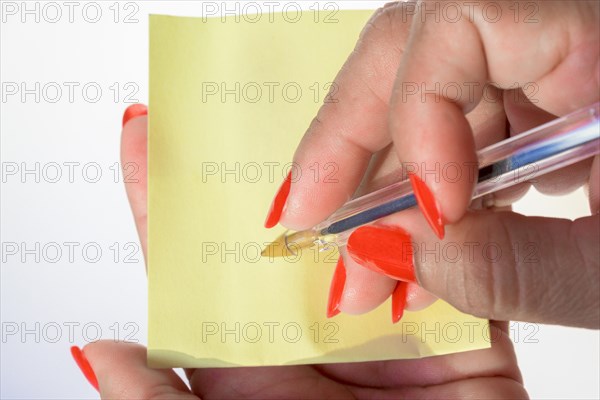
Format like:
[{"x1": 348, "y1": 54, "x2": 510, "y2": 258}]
[{"x1": 347, "y1": 225, "x2": 416, "y2": 282}]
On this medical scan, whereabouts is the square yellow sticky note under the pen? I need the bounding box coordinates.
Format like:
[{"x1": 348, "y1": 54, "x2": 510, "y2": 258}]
[{"x1": 148, "y1": 11, "x2": 490, "y2": 367}]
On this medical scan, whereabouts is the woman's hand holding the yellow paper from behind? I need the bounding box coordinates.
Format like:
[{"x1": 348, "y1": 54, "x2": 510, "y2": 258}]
[{"x1": 73, "y1": 106, "x2": 527, "y2": 400}]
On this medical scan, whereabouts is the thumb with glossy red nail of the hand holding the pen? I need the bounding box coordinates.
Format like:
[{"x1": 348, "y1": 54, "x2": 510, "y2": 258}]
[{"x1": 348, "y1": 210, "x2": 600, "y2": 328}]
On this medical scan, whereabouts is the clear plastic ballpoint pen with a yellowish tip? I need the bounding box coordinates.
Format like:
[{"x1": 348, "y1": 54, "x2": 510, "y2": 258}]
[{"x1": 262, "y1": 103, "x2": 600, "y2": 257}]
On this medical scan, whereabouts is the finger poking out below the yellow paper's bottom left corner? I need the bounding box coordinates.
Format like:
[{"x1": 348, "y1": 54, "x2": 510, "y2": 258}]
[{"x1": 77, "y1": 340, "x2": 198, "y2": 400}]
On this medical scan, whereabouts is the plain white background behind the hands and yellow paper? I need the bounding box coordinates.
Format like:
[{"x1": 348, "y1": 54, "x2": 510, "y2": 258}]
[{"x1": 0, "y1": 1, "x2": 600, "y2": 399}]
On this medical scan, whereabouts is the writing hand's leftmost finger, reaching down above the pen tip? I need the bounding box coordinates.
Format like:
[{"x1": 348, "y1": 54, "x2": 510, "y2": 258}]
[{"x1": 268, "y1": 3, "x2": 409, "y2": 230}]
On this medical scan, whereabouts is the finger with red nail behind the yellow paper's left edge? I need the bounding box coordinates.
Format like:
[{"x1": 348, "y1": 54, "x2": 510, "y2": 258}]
[{"x1": 121, "y1": 104, "x2": 148, "y2": 257}]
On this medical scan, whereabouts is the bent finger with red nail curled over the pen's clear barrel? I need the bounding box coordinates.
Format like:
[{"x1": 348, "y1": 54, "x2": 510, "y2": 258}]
[{"x1": 389, "y1": 3, "x2": 486, "y2": 236}]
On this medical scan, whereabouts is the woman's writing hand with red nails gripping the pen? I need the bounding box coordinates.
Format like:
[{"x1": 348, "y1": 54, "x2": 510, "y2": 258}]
[{"x1": 269, "y1": 1, "x2": 600, "y2": 328}]
